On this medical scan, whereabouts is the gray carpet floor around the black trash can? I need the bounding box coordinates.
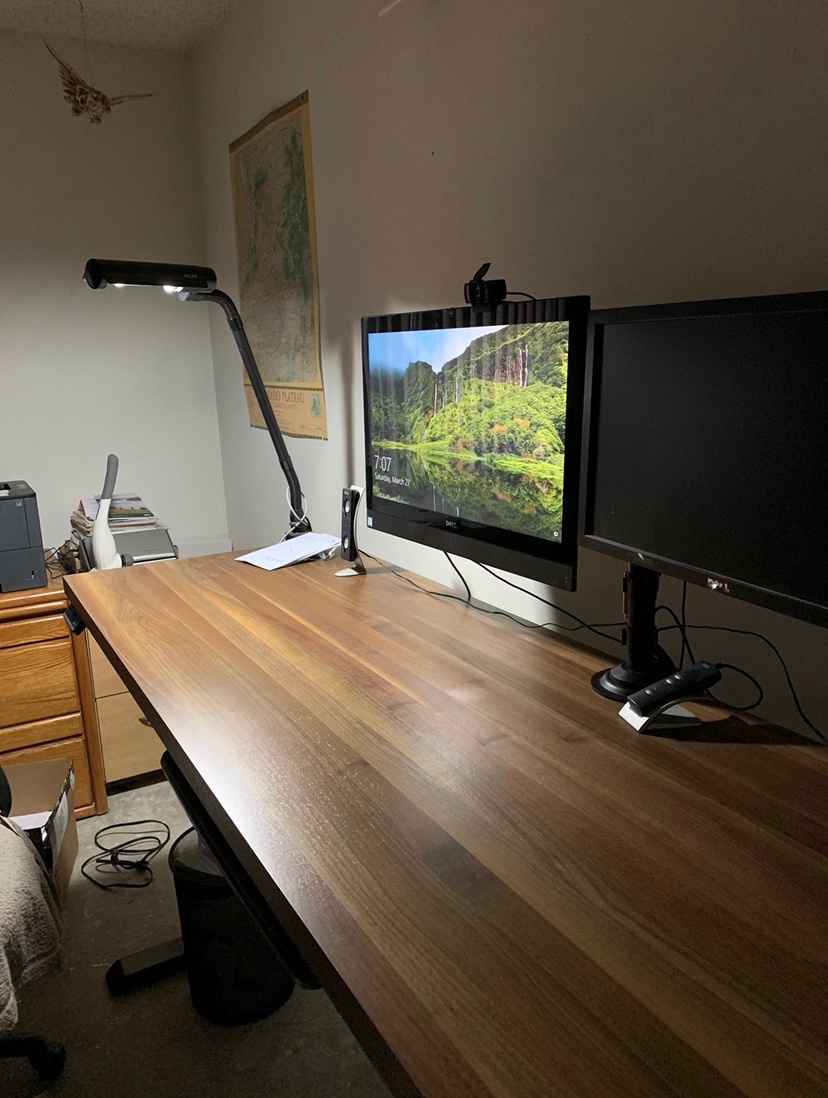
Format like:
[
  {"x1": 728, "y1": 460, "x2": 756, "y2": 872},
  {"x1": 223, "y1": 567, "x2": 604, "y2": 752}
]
[{"x1": 0, "y1": 782, "x2": 389, "y2": 1098}]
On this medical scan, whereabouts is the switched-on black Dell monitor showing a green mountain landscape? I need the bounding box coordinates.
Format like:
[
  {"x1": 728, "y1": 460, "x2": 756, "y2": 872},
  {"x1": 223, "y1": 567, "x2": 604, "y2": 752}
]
[{"x1": 362, "y1": 296, "x2": 590, "y2": 591}]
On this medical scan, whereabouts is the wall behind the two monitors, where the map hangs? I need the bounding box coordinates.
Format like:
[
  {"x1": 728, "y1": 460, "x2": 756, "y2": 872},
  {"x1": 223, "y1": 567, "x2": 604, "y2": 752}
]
[{"x1": 189, "y1": 0, "x2": 828, "y2": 730}]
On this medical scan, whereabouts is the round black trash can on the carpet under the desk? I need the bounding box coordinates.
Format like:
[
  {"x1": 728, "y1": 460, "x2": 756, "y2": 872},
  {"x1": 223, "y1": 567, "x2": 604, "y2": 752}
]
[{"x1": 169, "y1": 828, "x2": 293, "y2": 1024}]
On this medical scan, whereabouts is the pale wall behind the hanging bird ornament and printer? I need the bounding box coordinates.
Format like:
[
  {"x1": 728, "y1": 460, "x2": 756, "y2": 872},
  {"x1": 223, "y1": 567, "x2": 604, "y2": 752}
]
[{"x1": 0, "y1": 34, "x2": 226, "y2": 549}]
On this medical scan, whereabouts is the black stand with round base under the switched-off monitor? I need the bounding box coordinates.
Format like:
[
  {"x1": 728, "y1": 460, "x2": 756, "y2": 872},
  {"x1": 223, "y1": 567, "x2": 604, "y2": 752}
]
[{"x1": 592, "y1": 564, "x2": 675, "y2": 702}]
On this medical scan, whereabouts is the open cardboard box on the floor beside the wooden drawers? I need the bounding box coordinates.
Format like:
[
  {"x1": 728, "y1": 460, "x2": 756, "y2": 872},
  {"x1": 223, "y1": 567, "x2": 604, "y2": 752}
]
[{"x1": 3, "y1": 759, "x2": 78, "y2": 899}]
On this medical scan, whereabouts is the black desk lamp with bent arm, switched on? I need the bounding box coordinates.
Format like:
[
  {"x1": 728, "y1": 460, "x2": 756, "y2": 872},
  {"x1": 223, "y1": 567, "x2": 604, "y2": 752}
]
[{"x1": 83, "y1": 259, "x2": 311, "y2": 538}]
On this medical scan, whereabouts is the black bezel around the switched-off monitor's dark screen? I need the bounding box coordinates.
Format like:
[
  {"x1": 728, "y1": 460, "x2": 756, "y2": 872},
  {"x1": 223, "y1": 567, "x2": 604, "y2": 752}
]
[{"x1": 579, "y1": 291, "x2": 828, "y2": 627}]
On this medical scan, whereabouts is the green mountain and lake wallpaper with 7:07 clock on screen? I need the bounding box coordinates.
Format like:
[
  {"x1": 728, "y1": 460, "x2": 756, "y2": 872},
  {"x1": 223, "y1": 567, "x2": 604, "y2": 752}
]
[{"x1": 368, "y1": 321, "x2": 569, "y2": 540}]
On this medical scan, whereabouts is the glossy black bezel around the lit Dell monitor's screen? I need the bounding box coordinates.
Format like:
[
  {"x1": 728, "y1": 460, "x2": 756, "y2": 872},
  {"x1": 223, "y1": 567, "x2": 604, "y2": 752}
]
[{"x1": 361, "y1": 295, "x2": 590, "y2": 591}]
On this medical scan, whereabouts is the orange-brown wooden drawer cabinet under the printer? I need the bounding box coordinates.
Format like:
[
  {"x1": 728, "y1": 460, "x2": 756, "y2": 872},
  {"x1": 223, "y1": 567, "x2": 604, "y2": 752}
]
[{"x1": 0, "y1": 581, "x2": 107, "y2": 817}]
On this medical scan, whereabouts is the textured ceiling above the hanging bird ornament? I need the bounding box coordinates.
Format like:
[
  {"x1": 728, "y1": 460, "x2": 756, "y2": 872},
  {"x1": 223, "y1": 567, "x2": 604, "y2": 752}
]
[{"x1": 0, "y1": 0, "x2": 237, "y2": 53}]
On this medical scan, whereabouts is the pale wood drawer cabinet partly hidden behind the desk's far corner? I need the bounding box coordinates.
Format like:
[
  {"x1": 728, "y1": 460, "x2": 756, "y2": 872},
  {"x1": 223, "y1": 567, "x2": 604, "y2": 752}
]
[{"x1": 87, "y1": 635, "x2": 164, "y2": 782}]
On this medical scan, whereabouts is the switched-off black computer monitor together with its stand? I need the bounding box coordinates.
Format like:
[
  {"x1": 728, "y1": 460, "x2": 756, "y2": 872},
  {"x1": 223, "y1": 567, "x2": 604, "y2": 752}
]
[{"x1": 581, "y1": 292, "x2": 828, "y2": 696}]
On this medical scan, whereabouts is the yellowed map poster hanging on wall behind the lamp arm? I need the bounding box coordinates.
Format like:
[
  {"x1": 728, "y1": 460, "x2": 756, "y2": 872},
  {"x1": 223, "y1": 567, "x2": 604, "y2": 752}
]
[{"x1": 230, "y1": 92, "x2": 327, "y2": 438}]
